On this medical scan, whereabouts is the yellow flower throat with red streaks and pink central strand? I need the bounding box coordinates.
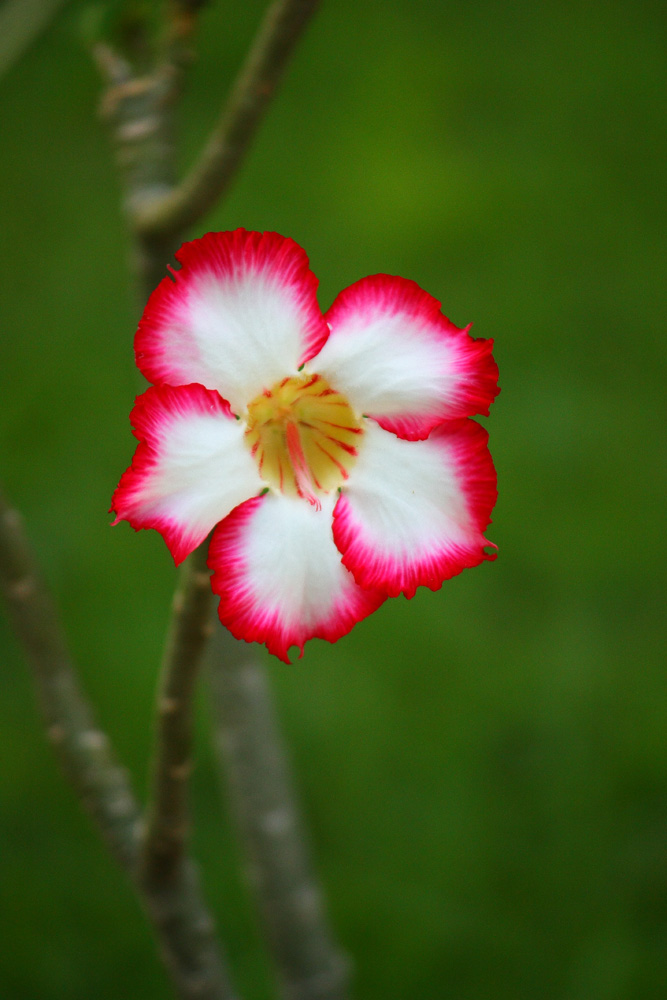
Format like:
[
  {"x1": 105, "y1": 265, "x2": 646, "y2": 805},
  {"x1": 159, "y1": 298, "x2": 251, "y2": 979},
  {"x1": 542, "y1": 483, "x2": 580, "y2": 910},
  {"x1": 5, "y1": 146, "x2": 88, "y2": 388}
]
[{"x1": 245, "y1": 374, "x2": 363, "y2": 508}]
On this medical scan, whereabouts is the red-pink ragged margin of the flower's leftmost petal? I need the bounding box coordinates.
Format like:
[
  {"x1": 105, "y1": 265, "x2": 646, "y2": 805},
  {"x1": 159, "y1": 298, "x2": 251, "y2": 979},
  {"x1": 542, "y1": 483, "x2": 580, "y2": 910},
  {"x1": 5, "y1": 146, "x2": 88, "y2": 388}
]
[{"x1": 109, "y1": 383, "x2": 234, "y2": 566}]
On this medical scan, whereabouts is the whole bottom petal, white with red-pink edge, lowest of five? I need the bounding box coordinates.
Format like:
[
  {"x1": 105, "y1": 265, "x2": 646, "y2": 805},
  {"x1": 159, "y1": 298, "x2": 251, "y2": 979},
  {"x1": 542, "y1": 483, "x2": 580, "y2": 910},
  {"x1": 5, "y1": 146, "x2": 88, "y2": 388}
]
[{"x1": 209, "y1": 493, "x2": 384, "y2": 663}]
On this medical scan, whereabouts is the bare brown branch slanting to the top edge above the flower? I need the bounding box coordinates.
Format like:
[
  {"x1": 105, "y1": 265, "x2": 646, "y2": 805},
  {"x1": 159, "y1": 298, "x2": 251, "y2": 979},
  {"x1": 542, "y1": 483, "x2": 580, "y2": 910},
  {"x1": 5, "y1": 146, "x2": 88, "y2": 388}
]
[{"x1": 133, "y1": 0, "x2": 319, "y2": 242}]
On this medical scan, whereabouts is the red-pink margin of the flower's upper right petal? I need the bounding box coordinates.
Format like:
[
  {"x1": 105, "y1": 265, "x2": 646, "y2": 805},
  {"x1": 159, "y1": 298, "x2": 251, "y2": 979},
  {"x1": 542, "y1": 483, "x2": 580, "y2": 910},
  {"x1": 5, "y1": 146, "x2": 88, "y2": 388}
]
[{"x1": 324, "y1": 274, "x2": 500, "y2": 441}]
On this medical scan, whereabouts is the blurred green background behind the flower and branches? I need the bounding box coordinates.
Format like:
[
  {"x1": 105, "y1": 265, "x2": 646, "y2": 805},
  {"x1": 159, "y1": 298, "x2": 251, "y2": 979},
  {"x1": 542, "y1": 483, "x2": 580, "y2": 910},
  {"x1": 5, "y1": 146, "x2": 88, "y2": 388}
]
[{"x1": 0, "y1": 0, "x2": 667, "y2": 1000}]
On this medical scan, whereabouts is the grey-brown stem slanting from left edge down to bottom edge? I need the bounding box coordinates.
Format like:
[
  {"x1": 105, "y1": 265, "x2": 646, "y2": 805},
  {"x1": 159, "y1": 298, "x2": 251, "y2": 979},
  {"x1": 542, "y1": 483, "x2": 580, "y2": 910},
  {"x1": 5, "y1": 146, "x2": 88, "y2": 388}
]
[{"x1": 0, "y1": 492, "x2": 240, "y2": 1000}]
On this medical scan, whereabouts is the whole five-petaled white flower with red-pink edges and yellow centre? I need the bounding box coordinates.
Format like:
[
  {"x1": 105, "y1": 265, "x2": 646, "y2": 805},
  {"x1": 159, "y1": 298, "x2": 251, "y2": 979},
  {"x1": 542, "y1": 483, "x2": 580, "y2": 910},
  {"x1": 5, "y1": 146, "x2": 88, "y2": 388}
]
[{"x1": 112, "y1": 229, "x2": 498, "y2": 662}]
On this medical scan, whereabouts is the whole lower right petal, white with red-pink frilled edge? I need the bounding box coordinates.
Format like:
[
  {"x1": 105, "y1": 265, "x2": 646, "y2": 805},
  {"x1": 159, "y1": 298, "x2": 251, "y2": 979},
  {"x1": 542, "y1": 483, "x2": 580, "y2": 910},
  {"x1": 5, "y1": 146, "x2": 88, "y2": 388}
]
[{"x1": 333, "y1": 420, "x2": 497, "y2": 597}]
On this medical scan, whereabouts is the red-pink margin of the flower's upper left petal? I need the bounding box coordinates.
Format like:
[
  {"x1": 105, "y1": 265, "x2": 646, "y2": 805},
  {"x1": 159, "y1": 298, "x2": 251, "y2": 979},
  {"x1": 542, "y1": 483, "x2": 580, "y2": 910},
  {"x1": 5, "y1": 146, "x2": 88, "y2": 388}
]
[{"x1": 134, "y1": 229, "x2": 329, "y2": 385}]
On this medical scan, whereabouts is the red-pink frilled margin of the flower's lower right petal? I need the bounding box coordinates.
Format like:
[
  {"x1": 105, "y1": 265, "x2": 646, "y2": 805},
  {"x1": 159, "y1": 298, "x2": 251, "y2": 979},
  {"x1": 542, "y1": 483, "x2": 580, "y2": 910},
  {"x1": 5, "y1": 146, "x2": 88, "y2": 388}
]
[{"x1": 333, "y1": 420, "x2": 498, "y2": 598}]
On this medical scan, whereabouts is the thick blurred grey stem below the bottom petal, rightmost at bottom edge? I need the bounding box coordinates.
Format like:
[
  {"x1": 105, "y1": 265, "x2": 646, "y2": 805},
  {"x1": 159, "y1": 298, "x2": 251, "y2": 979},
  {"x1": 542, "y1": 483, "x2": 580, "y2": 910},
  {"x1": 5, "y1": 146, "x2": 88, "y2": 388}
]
[{"x1": 209, "y1": 631, "x2": 348, "y2": 1000}]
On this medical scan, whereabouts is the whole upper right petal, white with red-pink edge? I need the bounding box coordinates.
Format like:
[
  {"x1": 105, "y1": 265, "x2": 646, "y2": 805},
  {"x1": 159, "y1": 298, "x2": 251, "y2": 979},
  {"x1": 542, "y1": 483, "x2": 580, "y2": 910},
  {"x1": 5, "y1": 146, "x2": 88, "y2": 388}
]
[{"x1": 311, "y1": 274, "x2": 499, "y2": 440}]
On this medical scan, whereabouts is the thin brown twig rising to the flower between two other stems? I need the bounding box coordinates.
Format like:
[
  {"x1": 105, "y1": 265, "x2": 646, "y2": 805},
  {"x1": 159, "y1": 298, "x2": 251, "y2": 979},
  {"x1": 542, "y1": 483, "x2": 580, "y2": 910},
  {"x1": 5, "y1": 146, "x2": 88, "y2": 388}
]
[{"x1": 142, "y1": 540, "x2": 213, "y2": 882}]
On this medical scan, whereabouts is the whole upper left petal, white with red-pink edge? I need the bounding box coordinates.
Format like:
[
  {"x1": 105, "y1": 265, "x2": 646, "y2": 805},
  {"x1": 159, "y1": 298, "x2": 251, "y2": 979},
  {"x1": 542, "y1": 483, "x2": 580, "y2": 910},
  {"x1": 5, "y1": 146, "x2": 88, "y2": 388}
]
[{"x1": 135, "y1": 229, "x2": 328, "y2": 413}]
